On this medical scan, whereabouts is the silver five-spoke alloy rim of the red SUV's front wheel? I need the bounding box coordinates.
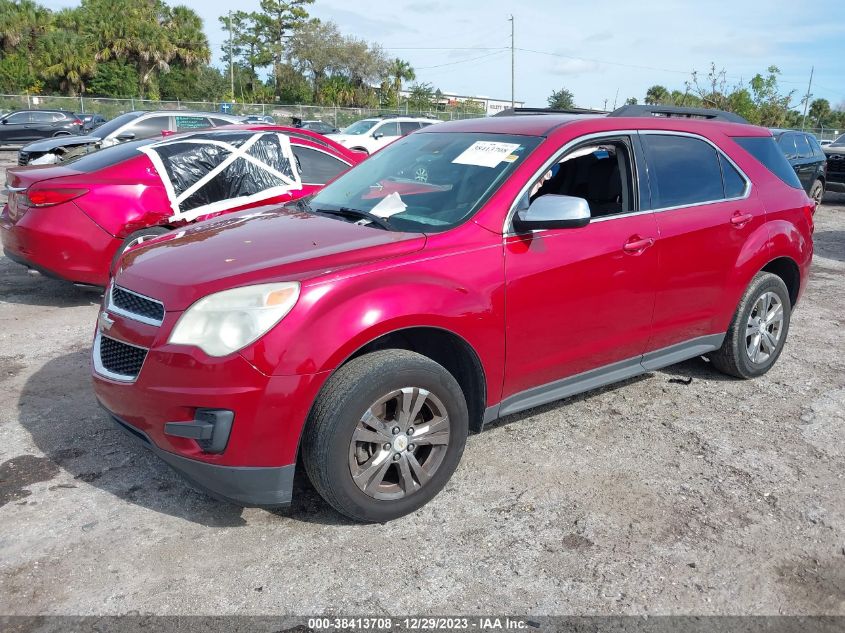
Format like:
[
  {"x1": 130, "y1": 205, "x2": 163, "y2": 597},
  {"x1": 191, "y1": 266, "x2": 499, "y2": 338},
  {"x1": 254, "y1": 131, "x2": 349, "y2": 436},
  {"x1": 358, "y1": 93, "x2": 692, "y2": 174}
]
[{"x1": 349, "y1": 387, "x2": 450, "y2": 500}]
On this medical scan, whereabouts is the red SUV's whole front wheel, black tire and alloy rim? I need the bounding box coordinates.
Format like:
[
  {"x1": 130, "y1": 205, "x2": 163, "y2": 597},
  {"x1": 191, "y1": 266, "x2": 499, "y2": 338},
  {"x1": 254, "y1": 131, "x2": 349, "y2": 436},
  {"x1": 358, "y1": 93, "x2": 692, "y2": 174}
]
[{"x1": 302, "y1": 350, "x2": 468, "y2": 523}]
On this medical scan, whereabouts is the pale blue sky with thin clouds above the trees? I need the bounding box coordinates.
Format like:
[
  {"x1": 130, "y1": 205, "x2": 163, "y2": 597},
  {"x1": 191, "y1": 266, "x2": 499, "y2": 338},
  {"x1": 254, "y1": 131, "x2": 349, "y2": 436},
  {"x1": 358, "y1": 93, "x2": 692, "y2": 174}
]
[{"x1": 43, "y1": 0, "x2": 845, "y2": 108}]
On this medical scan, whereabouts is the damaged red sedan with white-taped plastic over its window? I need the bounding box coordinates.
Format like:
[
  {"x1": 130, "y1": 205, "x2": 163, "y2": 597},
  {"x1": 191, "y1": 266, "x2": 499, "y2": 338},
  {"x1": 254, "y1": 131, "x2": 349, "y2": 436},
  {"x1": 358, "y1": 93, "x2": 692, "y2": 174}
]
[{"x1": 0, "y1": 126, "x2": 366, "y2": 287}]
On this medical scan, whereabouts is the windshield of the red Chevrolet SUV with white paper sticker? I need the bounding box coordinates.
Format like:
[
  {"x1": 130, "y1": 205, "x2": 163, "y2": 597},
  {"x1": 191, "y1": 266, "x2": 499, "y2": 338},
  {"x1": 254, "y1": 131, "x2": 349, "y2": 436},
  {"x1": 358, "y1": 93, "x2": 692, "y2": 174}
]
[{"x1": 311, "y1": 132, "x2": 542, "y2": 233}]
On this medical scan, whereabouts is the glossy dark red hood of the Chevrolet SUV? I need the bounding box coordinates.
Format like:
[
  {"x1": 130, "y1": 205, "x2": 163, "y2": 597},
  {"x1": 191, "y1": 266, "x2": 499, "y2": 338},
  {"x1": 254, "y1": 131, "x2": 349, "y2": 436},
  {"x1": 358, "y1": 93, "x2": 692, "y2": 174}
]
[{"x1": 115, "y1": 207, "x2": 426, "y2": 310}]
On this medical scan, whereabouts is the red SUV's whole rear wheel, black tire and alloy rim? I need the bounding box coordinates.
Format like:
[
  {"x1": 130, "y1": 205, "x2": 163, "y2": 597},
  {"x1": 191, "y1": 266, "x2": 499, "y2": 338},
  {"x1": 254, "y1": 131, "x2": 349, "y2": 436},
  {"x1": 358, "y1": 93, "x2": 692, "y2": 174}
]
[{"x1": 710, "y1": 272, "x2": 792, "y2": 378}]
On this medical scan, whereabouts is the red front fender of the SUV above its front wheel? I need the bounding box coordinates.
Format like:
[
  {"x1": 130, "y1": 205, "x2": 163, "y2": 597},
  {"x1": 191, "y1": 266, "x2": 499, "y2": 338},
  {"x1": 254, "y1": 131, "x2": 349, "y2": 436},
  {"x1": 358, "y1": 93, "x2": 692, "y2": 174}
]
[{"x1": 234, "y1": 233, "x2": 505, "y2": 402}]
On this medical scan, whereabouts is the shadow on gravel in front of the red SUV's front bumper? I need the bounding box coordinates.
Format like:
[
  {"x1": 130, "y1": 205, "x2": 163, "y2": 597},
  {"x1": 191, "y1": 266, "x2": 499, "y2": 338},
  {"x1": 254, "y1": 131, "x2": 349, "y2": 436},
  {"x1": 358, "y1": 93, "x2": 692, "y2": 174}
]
[{"x1": 18, "y1": 349, "x2": 348, "y2": 527}]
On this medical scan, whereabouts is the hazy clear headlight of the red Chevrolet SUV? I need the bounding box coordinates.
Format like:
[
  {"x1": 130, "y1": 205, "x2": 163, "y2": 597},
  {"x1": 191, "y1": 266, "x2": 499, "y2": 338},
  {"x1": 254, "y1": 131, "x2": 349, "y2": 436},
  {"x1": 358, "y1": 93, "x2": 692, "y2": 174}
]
[{"x1": 168, "y1": 282, "x2": 299, "y2": 356}]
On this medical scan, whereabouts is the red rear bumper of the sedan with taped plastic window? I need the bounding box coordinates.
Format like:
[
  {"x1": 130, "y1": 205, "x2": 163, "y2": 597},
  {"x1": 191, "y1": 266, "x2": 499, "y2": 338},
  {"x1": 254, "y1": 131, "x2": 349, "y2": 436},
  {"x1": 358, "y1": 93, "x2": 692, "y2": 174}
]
[{"x1": 0, "y1": 202, "x2": 122, "y2": 286}]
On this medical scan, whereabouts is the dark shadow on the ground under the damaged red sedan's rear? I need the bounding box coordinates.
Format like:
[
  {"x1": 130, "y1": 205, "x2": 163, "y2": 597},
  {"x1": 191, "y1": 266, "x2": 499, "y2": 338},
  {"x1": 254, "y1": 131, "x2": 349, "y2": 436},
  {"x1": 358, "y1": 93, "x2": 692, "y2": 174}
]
[{"x1": 0, "y1": 256, "x2": 103, "y2": 308}]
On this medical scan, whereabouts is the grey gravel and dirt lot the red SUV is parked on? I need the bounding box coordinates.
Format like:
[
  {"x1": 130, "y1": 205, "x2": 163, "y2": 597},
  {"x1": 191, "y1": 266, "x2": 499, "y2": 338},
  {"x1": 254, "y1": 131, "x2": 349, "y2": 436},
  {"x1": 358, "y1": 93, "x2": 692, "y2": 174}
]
[{"x1": 0, "y1": 146, "x2": 845, "y2": 615}]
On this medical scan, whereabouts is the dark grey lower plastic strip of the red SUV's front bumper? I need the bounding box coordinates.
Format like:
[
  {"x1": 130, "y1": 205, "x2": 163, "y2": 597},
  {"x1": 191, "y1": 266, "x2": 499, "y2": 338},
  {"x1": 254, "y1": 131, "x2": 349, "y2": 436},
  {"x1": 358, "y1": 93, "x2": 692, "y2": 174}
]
[{"x1": 109, "y1": 411, "x2": 295, "y2": 507}]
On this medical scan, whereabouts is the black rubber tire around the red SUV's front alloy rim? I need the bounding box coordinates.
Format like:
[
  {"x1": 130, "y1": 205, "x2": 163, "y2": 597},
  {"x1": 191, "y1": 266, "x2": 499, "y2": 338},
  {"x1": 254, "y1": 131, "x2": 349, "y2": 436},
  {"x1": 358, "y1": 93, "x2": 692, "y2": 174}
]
[{"x1": 302, "y1": 350, "x2": 469, "y2": 523}]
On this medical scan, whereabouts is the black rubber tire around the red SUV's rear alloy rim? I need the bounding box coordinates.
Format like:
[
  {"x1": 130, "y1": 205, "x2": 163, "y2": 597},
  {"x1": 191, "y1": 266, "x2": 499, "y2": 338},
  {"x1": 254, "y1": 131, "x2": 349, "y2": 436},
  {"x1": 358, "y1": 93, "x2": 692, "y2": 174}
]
[{"x1": 708, "y1": 272, "x2": 792, "y2": 379}]
